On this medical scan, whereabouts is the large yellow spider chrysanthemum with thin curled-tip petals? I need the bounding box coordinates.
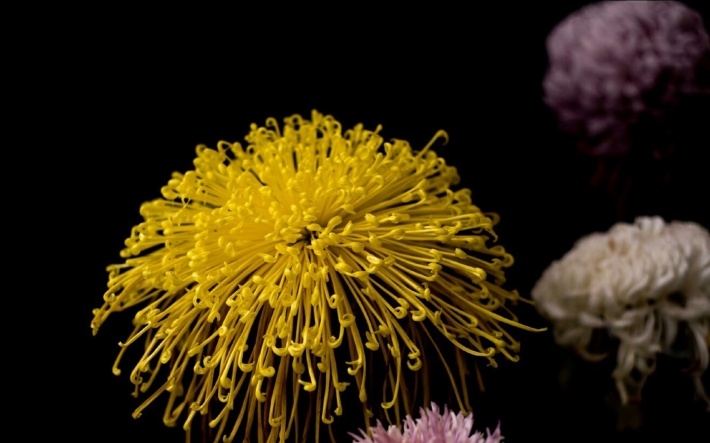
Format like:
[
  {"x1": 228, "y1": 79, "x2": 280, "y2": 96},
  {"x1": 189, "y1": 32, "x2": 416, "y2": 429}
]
[{"x1": 92, "y1": 111, "x2": 530, "y2": 441}]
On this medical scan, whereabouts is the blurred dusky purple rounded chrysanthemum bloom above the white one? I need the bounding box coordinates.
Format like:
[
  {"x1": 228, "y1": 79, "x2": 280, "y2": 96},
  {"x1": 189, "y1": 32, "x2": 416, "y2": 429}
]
[{"x1": 544, "y1": 1, "x2": 710, "y2": 155}]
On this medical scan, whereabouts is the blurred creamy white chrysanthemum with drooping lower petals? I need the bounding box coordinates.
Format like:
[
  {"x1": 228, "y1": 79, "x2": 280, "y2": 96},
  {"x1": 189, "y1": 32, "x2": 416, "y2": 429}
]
[{"x1": 532, "y1": 217, "x2": 710, "y2": 405}]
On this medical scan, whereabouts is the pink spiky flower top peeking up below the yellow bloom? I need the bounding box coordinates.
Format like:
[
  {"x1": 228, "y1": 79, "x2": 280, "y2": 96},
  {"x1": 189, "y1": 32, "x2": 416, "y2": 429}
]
[{"x1": 350, "y1": 403, "x2": 503, "y2": 443}]
